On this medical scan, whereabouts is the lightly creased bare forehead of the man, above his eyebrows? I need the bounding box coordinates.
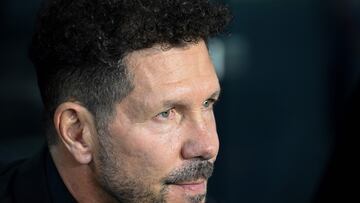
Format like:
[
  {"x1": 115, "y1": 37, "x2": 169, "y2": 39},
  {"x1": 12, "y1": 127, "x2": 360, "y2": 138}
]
[{"x1": 126, "y1": 41, "x2": 218, "y2": 91}]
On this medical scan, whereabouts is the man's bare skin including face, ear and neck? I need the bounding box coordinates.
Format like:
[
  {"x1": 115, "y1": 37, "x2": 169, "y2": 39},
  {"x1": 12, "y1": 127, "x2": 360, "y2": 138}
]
[{"x1": 50, "y1": 41, "x2": 220, "y2": 202}]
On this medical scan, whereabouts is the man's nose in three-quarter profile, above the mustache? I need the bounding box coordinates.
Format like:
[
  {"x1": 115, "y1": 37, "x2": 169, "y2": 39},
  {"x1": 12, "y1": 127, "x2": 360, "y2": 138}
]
[{"x1": 181, "y1": 115, "x2": 219, "y2": 160}]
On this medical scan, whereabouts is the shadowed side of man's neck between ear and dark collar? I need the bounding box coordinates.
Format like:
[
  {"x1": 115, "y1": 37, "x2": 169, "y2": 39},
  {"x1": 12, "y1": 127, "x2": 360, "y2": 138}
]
[{"x1": 50, "y1": 144, "x2": 115, "y2": 203}]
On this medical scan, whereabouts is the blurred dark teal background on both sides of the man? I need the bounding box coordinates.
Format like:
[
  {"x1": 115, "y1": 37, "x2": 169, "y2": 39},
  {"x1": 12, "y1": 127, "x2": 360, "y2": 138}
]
[{"x1": 0, "y1": 0, "x2": 360, "y2": 203}]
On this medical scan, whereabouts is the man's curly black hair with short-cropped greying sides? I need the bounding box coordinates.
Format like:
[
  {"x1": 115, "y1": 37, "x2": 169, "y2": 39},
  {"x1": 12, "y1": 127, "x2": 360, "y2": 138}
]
[{"x1": 29, "y1": 0, "x2": 231, "y2": 144}]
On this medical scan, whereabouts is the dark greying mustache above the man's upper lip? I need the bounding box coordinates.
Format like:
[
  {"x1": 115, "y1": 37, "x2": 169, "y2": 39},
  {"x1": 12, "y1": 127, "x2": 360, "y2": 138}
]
[{"x1": 163, "y1": 160, "x2": 214, "y2": 184}]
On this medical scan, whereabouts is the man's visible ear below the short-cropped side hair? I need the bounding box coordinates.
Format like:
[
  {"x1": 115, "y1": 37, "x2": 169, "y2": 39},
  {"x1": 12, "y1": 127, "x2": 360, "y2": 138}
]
[{"x1": 54, "y1": 102, "x2": 96, "y2": 164}]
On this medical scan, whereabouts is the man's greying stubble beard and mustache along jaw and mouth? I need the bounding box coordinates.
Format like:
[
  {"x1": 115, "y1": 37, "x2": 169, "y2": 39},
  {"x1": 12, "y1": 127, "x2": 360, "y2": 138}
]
[{"x1": 95, "y1": 126, "x2": 214, "y2": 203}]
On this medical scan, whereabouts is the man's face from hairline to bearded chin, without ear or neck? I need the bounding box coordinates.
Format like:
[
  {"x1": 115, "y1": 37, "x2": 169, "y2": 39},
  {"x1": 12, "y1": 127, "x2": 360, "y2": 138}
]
[{"x1": 95, "y1": 41, "x2": 220, "y2": 202}]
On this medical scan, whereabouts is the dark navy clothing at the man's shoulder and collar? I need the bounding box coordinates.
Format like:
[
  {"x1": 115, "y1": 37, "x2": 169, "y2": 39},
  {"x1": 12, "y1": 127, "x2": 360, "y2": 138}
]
[{"x1": 0, "y1": 148, "x2": 76, "y2": 203}]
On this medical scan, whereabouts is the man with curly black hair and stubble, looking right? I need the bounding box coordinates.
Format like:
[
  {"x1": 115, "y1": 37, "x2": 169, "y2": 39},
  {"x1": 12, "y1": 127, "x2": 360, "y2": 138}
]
[{"x1": 0, "y1": 0, "x2": 230, "y2": 203}]
